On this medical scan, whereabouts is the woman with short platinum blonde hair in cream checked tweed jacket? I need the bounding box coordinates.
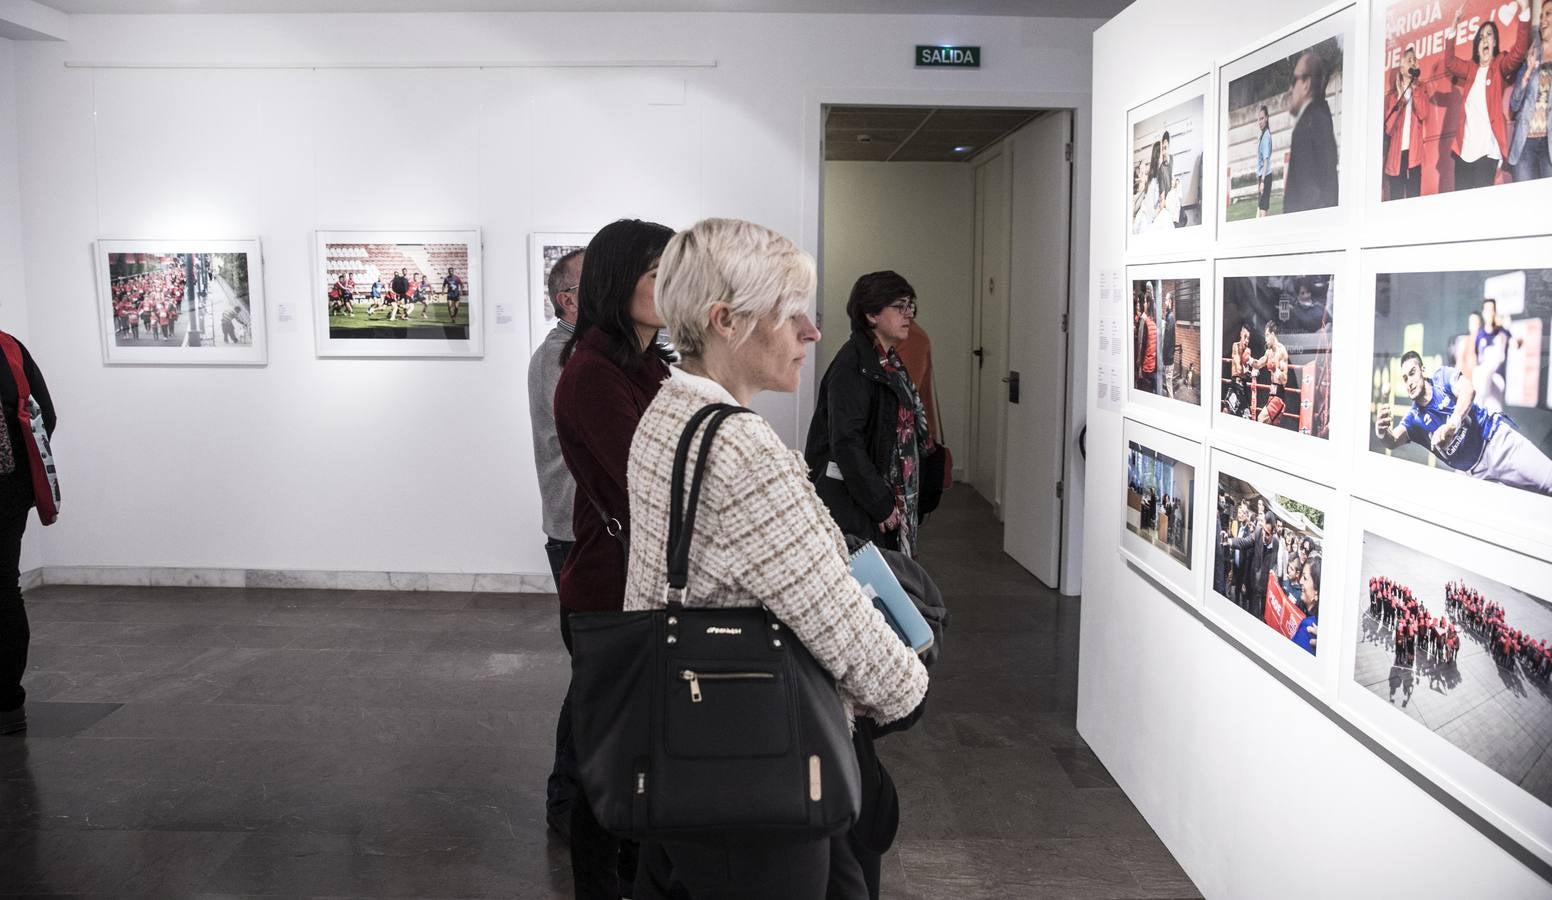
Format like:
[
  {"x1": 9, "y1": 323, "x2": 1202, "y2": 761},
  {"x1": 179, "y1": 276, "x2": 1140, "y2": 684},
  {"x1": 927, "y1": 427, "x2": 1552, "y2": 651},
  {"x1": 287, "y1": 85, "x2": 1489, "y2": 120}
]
[{"x1": 625, "y1": 219, "x2": 927, "y2": 900}]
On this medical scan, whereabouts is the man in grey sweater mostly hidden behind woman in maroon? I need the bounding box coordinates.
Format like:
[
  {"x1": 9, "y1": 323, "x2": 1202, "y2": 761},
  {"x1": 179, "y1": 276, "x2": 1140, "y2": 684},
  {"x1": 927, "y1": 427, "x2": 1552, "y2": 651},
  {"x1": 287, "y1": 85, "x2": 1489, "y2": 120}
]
[{"x1": 528, "y1": 243, "x2": 582, "y2": 838}]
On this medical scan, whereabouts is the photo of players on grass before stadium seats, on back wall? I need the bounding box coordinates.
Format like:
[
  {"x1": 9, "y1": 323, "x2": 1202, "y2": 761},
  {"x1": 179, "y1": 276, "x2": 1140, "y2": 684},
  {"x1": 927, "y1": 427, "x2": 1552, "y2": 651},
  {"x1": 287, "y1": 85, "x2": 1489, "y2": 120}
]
[{"x1": 323, "y1": 244, "x2": 472, "y2": 340}]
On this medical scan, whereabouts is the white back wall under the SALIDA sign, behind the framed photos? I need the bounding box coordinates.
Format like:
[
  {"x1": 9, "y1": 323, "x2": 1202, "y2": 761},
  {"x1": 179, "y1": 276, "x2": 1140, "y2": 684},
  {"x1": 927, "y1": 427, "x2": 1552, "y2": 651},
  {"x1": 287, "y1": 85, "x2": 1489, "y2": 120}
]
[{"x1": 0, "y1": 14, "x2": 1097, "y2": 579}]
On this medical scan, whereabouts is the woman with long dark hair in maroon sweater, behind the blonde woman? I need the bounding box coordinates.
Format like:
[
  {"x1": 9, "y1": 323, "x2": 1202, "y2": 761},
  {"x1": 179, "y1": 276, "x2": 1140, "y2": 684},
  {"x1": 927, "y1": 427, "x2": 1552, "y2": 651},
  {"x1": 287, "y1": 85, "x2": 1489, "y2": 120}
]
[{"x1": 556, "y1": 219, "x2": 674, "y2": 900}]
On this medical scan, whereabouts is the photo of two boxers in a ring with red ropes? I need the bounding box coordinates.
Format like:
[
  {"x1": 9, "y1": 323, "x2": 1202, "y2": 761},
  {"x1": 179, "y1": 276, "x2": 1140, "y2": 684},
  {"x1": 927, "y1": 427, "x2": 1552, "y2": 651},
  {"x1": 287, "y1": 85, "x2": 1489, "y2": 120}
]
[{"x1": 1218, "y1": 275, "x2": 1336, "y2": 439}]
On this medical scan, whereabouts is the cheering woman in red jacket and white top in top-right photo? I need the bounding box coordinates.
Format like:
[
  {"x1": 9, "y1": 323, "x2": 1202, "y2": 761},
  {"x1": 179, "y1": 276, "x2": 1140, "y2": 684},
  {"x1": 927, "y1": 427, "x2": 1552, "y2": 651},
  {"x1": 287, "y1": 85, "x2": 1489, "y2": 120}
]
[{"x1": 1445, "y1": 0, "x2": 1530, "y2": 191}]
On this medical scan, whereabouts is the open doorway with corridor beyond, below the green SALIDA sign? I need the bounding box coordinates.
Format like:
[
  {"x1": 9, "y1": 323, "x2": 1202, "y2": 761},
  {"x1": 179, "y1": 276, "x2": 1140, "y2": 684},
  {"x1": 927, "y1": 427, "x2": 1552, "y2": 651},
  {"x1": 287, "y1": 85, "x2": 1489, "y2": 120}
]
[{"x1": 813, "y1": 106, "x2": 1072, "y2": 587}]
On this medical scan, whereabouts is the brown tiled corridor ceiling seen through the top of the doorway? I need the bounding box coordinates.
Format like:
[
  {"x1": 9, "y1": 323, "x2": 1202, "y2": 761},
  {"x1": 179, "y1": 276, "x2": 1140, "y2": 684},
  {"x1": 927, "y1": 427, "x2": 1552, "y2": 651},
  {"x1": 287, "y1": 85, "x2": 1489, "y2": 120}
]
[{"x1": 824, "y1": 106, "x2": 1044, "y2": 163}]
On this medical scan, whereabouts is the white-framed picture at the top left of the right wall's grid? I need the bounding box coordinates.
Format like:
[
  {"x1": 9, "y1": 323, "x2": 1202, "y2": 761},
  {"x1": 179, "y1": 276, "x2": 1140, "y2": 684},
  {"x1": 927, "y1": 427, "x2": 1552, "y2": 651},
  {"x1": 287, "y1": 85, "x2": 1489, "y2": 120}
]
[{"x1": 1124, "y1": 73, "x2": 1218, "y2": 261}]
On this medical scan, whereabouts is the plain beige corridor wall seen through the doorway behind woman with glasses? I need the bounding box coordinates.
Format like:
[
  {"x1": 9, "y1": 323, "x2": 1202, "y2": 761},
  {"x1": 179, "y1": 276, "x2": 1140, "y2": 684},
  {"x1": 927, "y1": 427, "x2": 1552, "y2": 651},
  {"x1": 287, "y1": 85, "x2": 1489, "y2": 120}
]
[{"x1": 804, "y1": 161, "x2": 975, "y2": 452}]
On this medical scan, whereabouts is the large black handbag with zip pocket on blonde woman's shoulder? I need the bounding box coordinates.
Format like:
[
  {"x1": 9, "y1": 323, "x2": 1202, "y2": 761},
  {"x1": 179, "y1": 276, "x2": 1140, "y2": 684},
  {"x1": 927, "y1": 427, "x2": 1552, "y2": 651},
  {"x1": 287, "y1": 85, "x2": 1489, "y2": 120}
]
[{"x1": 571, "y1": 403, "x2": 861, "y2": 841}]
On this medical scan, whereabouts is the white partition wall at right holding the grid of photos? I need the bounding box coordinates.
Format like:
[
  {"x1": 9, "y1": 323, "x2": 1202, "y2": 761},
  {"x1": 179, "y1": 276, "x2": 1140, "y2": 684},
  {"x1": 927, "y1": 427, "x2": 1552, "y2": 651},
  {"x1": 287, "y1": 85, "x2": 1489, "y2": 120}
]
[{"x1": 1079, "y1": 0, "x2": 1549, "y2": 898}]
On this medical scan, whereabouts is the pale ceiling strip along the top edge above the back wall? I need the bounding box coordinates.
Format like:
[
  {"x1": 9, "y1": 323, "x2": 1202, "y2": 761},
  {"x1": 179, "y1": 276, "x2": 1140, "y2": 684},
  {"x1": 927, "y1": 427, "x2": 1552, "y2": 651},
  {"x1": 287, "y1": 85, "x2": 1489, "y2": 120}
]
[{"x1": 39, "y1": 0, "x2": 1131, "y2": 19}]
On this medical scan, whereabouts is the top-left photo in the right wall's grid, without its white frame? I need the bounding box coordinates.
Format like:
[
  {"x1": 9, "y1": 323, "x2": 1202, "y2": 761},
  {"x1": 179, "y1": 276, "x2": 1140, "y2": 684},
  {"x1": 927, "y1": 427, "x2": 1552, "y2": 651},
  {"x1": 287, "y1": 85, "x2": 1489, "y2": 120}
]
[{"x1": 1130, "y1": 93, "x2": 1212, "y2": 234}]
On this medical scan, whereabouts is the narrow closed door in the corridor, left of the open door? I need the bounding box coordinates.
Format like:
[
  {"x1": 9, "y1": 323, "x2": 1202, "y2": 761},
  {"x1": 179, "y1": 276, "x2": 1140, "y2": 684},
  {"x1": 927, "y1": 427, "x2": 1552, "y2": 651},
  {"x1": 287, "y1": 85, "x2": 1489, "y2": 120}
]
[{"x1": 968, "y1": 149, "x2": 1009, "y2": 518}]
